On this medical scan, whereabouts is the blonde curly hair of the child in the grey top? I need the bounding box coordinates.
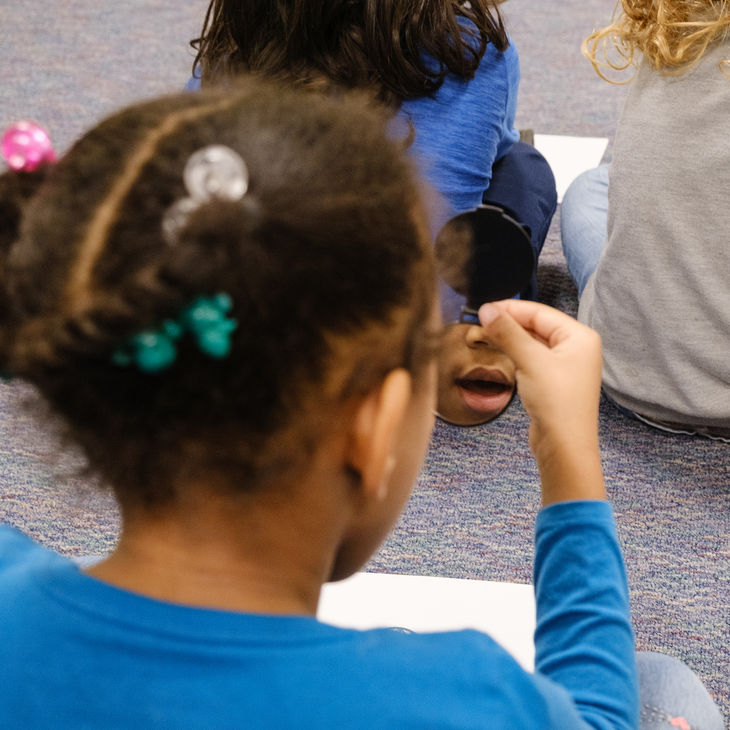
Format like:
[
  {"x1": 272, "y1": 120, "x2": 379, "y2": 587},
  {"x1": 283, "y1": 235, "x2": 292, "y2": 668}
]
[{"x1": 582, "y1": 0, "x2": 730, "y2": 83}]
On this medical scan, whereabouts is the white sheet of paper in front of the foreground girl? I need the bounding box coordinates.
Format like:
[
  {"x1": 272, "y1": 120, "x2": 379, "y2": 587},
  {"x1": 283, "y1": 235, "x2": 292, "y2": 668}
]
[{"x1": 317, "y1": 573, "x2": 535, "y2": 671}]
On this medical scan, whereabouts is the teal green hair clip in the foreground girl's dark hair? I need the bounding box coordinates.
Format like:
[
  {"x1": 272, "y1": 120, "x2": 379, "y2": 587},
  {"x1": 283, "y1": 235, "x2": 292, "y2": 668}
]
[{"x1": 112, "y1": 292, "x2": 238, "y2": 373}]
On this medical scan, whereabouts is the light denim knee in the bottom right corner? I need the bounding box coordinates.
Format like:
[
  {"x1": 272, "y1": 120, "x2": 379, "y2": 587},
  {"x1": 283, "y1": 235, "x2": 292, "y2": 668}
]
[{"x1": 636, "y1": 652, "x2": 722, "y2": 730}]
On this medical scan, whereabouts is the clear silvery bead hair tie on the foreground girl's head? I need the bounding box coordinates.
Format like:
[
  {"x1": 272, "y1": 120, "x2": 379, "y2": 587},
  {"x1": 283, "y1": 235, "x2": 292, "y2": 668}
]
[{"x1": 162, "y1": 144, "x2": 249, "y2": 245}]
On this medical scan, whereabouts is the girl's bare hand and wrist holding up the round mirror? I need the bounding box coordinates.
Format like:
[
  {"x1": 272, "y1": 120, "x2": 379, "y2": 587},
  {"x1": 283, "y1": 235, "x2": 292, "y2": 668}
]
[{"x1": 479, "y1": 299, "x2": 605, "y2": 504}]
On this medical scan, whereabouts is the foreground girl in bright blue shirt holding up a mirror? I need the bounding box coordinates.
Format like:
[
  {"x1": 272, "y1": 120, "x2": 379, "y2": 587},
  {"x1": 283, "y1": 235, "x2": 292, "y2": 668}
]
[{"x1": 0, "y1": 79, "x2": 716, "y2": 730}]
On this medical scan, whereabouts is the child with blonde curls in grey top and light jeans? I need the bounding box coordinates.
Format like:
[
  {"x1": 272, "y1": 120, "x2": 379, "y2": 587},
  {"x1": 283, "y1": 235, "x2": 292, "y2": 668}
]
[{"x1": 561, "y1": 0, "x2": 730, "y2": 441}]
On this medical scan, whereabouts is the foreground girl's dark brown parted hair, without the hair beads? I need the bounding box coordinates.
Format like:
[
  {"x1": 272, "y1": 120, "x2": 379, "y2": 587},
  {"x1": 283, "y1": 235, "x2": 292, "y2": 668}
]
[{"x1": 0, "y1": 79, "x2": 434, "y2": 505}]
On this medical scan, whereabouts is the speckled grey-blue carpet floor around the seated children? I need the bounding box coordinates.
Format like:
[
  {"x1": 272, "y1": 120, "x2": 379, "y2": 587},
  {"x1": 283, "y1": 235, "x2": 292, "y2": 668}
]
[{"x1": 0, "y1": 0, "x2": 730, "y2": 716}]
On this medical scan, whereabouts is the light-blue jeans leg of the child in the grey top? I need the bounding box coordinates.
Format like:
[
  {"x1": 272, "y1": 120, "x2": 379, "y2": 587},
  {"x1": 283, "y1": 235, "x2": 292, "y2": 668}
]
[{"x1": 560, "y1": 165, "x2": 608, "y2": 296}]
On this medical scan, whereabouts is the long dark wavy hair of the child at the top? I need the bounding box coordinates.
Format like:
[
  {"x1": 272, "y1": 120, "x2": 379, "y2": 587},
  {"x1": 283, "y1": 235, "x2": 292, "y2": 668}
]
[{"x1": 191, "y1": 0, "x2": 509, "y2": 106}]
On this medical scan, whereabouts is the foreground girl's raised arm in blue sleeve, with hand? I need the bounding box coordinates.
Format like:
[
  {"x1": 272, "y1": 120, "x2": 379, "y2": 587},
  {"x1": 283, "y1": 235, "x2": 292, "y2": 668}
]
[{"x1": 480, "y1": 300, "x2": 638, "y2": 728}]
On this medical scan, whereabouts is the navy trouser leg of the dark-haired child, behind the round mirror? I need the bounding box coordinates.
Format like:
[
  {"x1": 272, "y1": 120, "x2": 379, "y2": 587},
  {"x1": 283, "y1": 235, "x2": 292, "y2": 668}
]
[{"x1": 482, "y1": 142, "x2": 558, "y2": 299}]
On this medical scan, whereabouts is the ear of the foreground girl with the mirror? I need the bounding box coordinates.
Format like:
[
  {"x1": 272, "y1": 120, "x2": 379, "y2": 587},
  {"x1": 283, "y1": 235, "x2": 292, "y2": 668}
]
[{"x1": 348, "y1": 368, "x2": 412, "y2": 501}]
